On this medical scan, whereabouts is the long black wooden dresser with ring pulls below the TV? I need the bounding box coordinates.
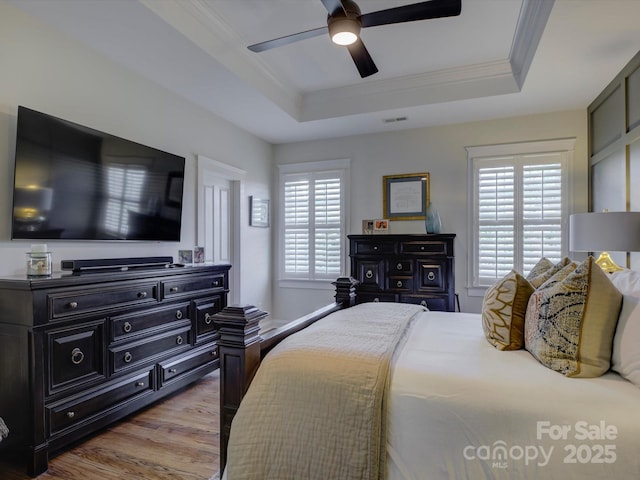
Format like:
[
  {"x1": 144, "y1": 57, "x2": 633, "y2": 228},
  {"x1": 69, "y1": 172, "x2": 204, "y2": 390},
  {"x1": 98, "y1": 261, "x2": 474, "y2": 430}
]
[{"x1": 0, "y1": 265, "x2": 231, "y2": 475}]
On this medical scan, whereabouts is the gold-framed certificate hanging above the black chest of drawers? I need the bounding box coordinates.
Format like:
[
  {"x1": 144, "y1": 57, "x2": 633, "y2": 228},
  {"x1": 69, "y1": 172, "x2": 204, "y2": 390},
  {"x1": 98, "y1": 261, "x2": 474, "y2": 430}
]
[{"x1": 382, "y1": 172, "x2": 429, "y2": 220}]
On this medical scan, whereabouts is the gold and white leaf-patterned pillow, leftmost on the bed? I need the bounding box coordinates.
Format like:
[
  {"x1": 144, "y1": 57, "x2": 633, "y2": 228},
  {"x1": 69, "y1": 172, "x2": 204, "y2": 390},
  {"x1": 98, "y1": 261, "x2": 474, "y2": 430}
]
[{"x1": 482, "y1": 270, "x2": 533, "y2": 350}]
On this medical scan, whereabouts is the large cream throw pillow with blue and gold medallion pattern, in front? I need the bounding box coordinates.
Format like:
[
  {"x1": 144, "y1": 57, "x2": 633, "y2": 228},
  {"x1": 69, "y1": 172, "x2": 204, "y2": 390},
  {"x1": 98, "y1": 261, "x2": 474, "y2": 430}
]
[{"x1": 525, "y1": 257, "x2": 622, "y2": 377}]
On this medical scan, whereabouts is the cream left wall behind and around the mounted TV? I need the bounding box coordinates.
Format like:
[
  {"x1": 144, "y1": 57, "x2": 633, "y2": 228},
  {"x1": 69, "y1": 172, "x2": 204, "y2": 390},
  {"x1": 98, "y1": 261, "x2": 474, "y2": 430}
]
[{"x1": 0, "y1": 2, "x2": 273, "y2": 310}]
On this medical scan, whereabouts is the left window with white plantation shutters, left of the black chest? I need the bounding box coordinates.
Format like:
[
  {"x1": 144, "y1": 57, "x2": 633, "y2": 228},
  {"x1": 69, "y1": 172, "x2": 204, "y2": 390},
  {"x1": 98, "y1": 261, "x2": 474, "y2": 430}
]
[{"x1": 280, "y1": 160, "x2": 349, "y2": 283}]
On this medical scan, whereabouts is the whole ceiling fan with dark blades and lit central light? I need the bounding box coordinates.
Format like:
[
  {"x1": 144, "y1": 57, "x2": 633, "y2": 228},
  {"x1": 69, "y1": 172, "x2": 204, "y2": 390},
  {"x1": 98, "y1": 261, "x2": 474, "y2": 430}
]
[{"x1": 248, "y1": 0, "x2": 462, "y2": 78}]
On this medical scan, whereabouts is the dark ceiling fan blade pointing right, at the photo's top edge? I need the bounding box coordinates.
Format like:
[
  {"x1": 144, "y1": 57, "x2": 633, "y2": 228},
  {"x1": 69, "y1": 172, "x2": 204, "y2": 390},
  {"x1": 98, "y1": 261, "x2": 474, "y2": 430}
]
[{"x1": 360, "y1": 0, "x2": 462, "y2": 28}]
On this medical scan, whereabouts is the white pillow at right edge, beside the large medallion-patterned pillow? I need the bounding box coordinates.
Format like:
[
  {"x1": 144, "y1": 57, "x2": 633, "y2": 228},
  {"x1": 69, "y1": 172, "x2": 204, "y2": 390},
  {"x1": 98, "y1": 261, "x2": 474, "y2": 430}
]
[{"x1": 611, "y1": 295, "x2": 640, "y2": 387}]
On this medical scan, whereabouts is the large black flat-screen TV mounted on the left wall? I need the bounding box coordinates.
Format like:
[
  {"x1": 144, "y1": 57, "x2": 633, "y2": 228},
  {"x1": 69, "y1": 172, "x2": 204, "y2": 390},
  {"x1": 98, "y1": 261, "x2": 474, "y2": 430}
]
[{"x1": 11, "y1": 106, "x2": 185, "y2": 242}]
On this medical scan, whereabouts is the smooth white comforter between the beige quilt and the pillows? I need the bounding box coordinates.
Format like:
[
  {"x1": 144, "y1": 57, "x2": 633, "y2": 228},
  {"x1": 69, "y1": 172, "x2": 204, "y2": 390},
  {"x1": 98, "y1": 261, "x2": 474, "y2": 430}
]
[{"x1": 387, "y1": 312, "x2": 640, "y2": 480}]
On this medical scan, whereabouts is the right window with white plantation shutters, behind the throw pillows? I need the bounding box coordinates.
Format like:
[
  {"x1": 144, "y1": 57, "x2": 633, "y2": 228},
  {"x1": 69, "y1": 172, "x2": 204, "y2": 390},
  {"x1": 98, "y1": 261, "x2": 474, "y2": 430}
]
[{"x1": 467, "y1": 140, "x2": 574, "y2": 295}]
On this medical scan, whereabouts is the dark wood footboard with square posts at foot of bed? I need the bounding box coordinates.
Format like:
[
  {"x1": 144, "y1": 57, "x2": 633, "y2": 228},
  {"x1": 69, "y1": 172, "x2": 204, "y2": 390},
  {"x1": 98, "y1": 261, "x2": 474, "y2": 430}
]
[{"x1": 214, "y1": 277, "x2": 358, "y2": 471}]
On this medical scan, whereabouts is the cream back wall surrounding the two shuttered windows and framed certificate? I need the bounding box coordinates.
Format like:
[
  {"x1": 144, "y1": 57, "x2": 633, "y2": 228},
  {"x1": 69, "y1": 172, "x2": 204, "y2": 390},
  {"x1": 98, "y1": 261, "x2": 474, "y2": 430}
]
[{"x1": 274, "y1": 106, "x2": 588, "y2": 319}]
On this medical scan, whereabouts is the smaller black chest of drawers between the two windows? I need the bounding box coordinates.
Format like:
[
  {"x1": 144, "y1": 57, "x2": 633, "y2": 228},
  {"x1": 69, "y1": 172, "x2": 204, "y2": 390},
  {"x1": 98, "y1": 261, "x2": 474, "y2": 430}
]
[{"x1": 349, "y1": 234, "x2": 456, "y2": 312}]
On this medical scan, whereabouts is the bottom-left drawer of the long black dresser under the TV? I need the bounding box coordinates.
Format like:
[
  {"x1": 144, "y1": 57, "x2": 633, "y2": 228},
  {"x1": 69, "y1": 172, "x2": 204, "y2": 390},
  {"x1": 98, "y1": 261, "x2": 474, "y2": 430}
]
[{"x1": 46, "y1": 370, "x2": 153, "y2": 435}]
